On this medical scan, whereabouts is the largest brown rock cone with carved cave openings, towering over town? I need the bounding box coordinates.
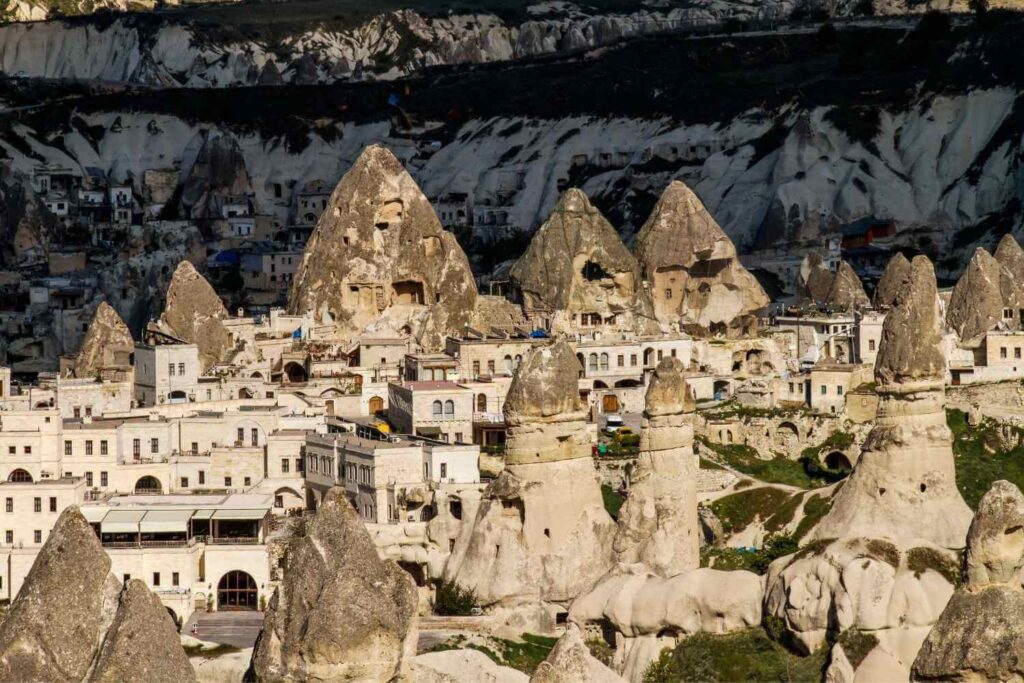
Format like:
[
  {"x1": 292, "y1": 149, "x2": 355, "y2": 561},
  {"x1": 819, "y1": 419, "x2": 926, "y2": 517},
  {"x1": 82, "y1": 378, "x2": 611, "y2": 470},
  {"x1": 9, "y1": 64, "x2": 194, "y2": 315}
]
[{"x1": 289, "y1": 145, "x2": 477, "y2": 350}]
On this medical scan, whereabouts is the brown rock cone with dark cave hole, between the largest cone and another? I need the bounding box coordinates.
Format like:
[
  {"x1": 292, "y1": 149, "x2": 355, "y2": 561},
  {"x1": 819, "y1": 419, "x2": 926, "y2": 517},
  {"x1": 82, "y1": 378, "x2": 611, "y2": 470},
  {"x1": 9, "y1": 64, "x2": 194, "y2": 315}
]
[{"x1": 509, "y1": 188, "x2": 659, "y2": 333}]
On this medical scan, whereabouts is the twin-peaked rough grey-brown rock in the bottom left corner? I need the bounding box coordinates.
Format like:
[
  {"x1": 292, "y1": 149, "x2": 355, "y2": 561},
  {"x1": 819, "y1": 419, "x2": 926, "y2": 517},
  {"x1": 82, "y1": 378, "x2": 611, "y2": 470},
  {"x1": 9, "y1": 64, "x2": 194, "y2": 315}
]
[{"x1": 0, "y1": 506, "x2": 196, "y2": 681}]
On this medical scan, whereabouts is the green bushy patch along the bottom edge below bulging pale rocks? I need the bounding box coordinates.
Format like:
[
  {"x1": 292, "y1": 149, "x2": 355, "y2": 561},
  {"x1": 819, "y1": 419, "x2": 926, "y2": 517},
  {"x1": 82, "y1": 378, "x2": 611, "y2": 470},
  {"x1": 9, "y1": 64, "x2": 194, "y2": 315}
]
[{"x1": 643, "y1": 628, "x2": 828, "y2": 683}]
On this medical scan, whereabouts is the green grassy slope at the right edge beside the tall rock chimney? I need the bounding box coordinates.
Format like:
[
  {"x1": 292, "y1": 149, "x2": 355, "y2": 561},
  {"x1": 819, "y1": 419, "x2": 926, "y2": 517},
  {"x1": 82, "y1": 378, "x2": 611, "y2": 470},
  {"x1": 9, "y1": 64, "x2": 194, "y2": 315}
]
[{"x1": 946, "y1": 410, "x2": 1024, "y2": 510}]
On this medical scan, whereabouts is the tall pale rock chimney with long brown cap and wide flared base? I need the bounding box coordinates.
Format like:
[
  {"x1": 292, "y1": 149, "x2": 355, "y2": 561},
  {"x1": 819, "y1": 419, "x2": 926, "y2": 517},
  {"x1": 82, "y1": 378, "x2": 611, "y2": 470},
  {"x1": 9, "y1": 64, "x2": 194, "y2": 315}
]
[{"x1": 814, "y1": 256, "x2": 971, "y2": 548}]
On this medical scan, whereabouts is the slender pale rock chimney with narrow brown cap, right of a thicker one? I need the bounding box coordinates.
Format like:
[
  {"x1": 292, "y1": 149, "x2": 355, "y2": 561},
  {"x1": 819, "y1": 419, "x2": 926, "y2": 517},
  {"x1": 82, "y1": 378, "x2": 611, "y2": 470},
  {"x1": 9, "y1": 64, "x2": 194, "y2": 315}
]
[{"x1": 613, "y1": 357, "x2": 700, "y2": 577}]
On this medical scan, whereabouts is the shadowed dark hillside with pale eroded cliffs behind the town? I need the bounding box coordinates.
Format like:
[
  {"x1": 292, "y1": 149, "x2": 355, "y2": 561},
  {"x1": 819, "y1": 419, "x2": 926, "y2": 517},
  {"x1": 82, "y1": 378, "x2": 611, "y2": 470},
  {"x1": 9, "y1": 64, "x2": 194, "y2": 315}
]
[{"x1": 0, "y1": 14, "x2": 1024, "y2": 274}]
